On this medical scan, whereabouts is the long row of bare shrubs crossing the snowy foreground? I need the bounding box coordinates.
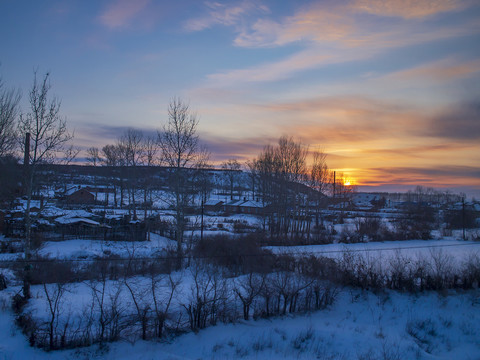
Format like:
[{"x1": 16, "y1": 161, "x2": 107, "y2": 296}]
[{"x1": 18, "y1": 243, "x2": 480, "y2": 349}]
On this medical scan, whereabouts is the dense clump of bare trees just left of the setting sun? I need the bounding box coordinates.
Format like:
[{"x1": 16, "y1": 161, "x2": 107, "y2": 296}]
[{"x1": 248, "y1": 136, "x2": 353, "y2": 241}]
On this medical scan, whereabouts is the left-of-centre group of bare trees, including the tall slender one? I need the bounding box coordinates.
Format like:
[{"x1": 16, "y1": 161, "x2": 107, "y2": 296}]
[{"x1": 87, "y1": 98, "x2": 210, "y2": 266}]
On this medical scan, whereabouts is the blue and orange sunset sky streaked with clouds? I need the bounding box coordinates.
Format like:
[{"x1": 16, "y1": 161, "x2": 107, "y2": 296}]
[{"x1": 0, "y1": 0, "x2": 480, "y2": 198}]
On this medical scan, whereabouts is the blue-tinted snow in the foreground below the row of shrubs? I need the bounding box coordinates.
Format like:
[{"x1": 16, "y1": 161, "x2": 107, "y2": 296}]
[{"x1": 0, "y1": 289, "x2": 480, "y2": 360}]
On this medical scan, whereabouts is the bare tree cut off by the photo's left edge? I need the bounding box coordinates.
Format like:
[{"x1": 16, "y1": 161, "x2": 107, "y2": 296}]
[{"x1": 0, "y1": 74, "x2": 20, "y2": 158}]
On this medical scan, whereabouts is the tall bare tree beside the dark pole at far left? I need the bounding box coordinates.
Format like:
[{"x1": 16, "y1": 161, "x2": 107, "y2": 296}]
[{"x1": 18, "y1": 71, "x2": 73, "y2": 298}]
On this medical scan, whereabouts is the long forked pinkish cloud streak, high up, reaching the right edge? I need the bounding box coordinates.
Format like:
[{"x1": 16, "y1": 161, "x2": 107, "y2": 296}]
[{"x1": 203, "y1": 4, "x2": 480, "y2": 87}]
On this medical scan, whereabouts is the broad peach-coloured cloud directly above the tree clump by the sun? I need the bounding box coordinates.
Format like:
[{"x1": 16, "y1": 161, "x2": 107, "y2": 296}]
[{"x1": 259, "y1": 95, "x2": 425, "y2": 144}]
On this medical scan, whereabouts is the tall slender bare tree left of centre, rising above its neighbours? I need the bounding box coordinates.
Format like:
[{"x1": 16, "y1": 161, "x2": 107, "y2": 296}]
[{"x1": 158, "y1": 98, "x2": 198, "y2": 268}]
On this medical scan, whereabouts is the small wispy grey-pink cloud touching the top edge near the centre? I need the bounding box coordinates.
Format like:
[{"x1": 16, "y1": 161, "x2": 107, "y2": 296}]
[{"x1": 183, "y1": 0, "x2": 268, "y2": 31}]
